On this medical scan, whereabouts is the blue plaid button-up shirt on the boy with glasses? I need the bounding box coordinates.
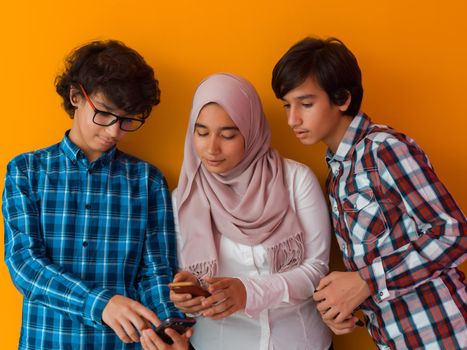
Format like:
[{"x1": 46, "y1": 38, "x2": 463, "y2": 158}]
[{"x1": 2, "y1": 133, "x2": 180, "y2": 350}]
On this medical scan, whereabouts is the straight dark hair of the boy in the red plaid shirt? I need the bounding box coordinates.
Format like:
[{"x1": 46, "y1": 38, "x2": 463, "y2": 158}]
[{"x1": 272, "y1": 38, "x2": 363, "y2": 116}]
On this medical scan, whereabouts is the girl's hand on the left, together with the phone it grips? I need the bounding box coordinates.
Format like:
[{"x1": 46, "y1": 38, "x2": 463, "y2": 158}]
[{"x1": 169, "y1": 271, "x2": 209, "y2": 314}]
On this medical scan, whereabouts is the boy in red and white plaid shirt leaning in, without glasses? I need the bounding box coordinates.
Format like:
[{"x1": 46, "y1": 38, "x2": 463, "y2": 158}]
[{"x1": 272, "y1": 38, "x2": 467, "y2": 349}]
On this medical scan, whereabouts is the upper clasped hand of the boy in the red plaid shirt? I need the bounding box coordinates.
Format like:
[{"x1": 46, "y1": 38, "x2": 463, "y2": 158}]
[{"x1": 313, "y1": 271, "x2": 371, "y2": 323}]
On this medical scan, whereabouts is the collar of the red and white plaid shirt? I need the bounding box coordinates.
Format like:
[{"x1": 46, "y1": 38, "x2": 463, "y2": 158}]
[{"x1": 326, "y1": 112, "x2": 371, "y2": 163}]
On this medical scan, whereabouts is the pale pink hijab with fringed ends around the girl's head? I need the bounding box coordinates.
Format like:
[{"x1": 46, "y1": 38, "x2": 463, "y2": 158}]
[{"x1": 177, "y1": 73, "x2": 305, "y2": 277}]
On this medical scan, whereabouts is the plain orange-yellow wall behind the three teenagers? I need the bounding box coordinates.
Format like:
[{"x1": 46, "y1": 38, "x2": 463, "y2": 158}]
[{"x1": 0, "y1": 0, "x2": 467, "y2": 350}]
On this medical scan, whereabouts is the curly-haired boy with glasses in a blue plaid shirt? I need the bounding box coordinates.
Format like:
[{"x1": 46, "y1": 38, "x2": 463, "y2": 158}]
[{"x1": 2, "y1": 41, "x2": 188, "y2": 349}]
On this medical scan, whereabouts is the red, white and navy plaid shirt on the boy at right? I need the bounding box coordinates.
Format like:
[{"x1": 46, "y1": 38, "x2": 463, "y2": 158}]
[{"x1": 326, "y1": 114, "x2": 467, "y2": 349}]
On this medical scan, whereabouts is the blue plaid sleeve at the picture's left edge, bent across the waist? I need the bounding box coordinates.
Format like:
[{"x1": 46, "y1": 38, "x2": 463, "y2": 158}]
[{"x1": 2, "y1": 157, "x2": 113, "y2": 327}]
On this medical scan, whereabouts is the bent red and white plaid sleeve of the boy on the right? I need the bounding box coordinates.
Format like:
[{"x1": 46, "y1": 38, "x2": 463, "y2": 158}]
[{"x1": 359, "y1": 138, "x2": 467, "y2": 301}]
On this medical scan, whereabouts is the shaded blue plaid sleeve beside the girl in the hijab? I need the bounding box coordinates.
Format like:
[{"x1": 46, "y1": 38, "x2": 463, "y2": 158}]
[{"x1": 138, "y1": 172, "x2": 182, "y2": 319}]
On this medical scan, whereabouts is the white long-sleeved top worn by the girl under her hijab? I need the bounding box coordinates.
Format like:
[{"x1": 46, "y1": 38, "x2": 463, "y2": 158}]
[{"x1": 172, "y1": 159, "x2": 331, "y2": 350}]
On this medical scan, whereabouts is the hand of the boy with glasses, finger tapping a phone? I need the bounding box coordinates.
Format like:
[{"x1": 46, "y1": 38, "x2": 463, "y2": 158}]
[{"x1": 102, "y1": 295, "x2": 160, "y2": 343}]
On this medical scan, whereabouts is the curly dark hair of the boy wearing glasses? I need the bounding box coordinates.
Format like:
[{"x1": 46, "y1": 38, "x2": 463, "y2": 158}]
[{"x1": 55, "y1": 40, "x2": 160, "y2": 118}]
